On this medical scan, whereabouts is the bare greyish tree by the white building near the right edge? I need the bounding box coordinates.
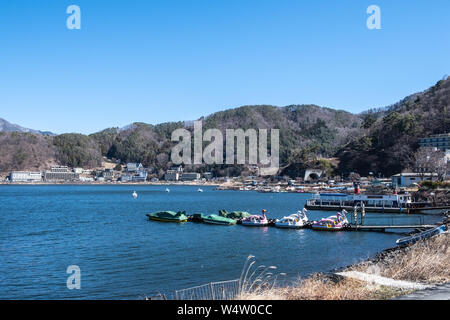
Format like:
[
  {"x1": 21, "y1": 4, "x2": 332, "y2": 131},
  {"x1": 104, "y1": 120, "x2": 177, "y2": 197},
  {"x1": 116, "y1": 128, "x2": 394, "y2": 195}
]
[{"x1": 414, "y1": 147, "x2": 447, "y2": 181}]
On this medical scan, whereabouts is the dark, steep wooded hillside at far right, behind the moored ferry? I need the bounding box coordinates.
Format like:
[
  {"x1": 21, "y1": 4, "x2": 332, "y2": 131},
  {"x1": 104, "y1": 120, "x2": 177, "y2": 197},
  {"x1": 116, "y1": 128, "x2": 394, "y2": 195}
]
[{"x1": 337, "y1": 78, "x2": 450, "y2": 176}]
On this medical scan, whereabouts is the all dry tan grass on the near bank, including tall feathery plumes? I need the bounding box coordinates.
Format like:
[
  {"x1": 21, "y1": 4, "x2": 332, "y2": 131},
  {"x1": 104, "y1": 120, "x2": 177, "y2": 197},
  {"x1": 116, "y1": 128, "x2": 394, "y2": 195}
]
[{"x1": 238, "y1": 234, "x2": 450, "y2": 300}]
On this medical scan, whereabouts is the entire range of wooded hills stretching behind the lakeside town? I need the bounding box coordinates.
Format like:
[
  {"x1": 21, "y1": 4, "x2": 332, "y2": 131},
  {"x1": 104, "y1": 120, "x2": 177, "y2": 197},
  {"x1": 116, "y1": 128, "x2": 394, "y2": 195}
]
[{"x1": 0, "y1": 78, "x2": 450, "y2": 176}]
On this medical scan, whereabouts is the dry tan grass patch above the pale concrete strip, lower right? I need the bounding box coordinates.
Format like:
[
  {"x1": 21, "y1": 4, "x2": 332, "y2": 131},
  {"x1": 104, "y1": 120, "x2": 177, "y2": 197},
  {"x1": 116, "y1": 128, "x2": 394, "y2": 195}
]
[{"x1": 351, "y1": 234, "x2": 450, "y2": 283}]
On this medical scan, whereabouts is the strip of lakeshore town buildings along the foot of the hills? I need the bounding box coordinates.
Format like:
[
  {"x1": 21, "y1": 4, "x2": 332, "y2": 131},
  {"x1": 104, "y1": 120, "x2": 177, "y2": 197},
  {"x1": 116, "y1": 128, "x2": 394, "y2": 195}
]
[{"x1": 0, "y1": 133, "x2": 450, "y2": 193}]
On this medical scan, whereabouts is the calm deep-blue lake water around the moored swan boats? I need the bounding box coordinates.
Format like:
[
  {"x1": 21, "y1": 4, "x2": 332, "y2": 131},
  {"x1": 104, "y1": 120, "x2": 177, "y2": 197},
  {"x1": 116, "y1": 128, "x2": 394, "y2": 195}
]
[{"x1": 0, "y1": 186, "x2": 438, "y2": 299}]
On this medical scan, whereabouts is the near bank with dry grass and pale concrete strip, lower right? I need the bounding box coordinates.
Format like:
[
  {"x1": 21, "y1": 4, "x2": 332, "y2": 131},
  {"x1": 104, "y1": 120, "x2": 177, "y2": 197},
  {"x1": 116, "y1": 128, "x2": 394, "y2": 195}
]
[{"x1": 238, "y1": 222, "x2": 450, "y2": 300}]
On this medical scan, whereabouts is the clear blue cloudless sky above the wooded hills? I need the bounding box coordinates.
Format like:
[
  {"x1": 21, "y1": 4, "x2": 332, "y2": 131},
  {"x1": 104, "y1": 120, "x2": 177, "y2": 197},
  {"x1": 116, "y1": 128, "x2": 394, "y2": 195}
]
[{"x1": 0, "y1": 0, "x2": 450, "y2": 133}]
